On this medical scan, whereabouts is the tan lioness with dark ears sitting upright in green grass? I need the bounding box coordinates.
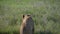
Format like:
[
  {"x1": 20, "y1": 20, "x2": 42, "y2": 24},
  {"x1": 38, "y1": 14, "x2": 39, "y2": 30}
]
[{"x1": 20, "y1": 15, "x2": 34, "y2": 34}]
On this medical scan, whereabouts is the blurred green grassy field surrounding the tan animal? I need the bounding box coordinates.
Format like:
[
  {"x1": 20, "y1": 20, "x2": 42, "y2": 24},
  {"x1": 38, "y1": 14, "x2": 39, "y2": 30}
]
[{"x1": 0, "y1": 0, "x2": 60, "y2": 34}]
